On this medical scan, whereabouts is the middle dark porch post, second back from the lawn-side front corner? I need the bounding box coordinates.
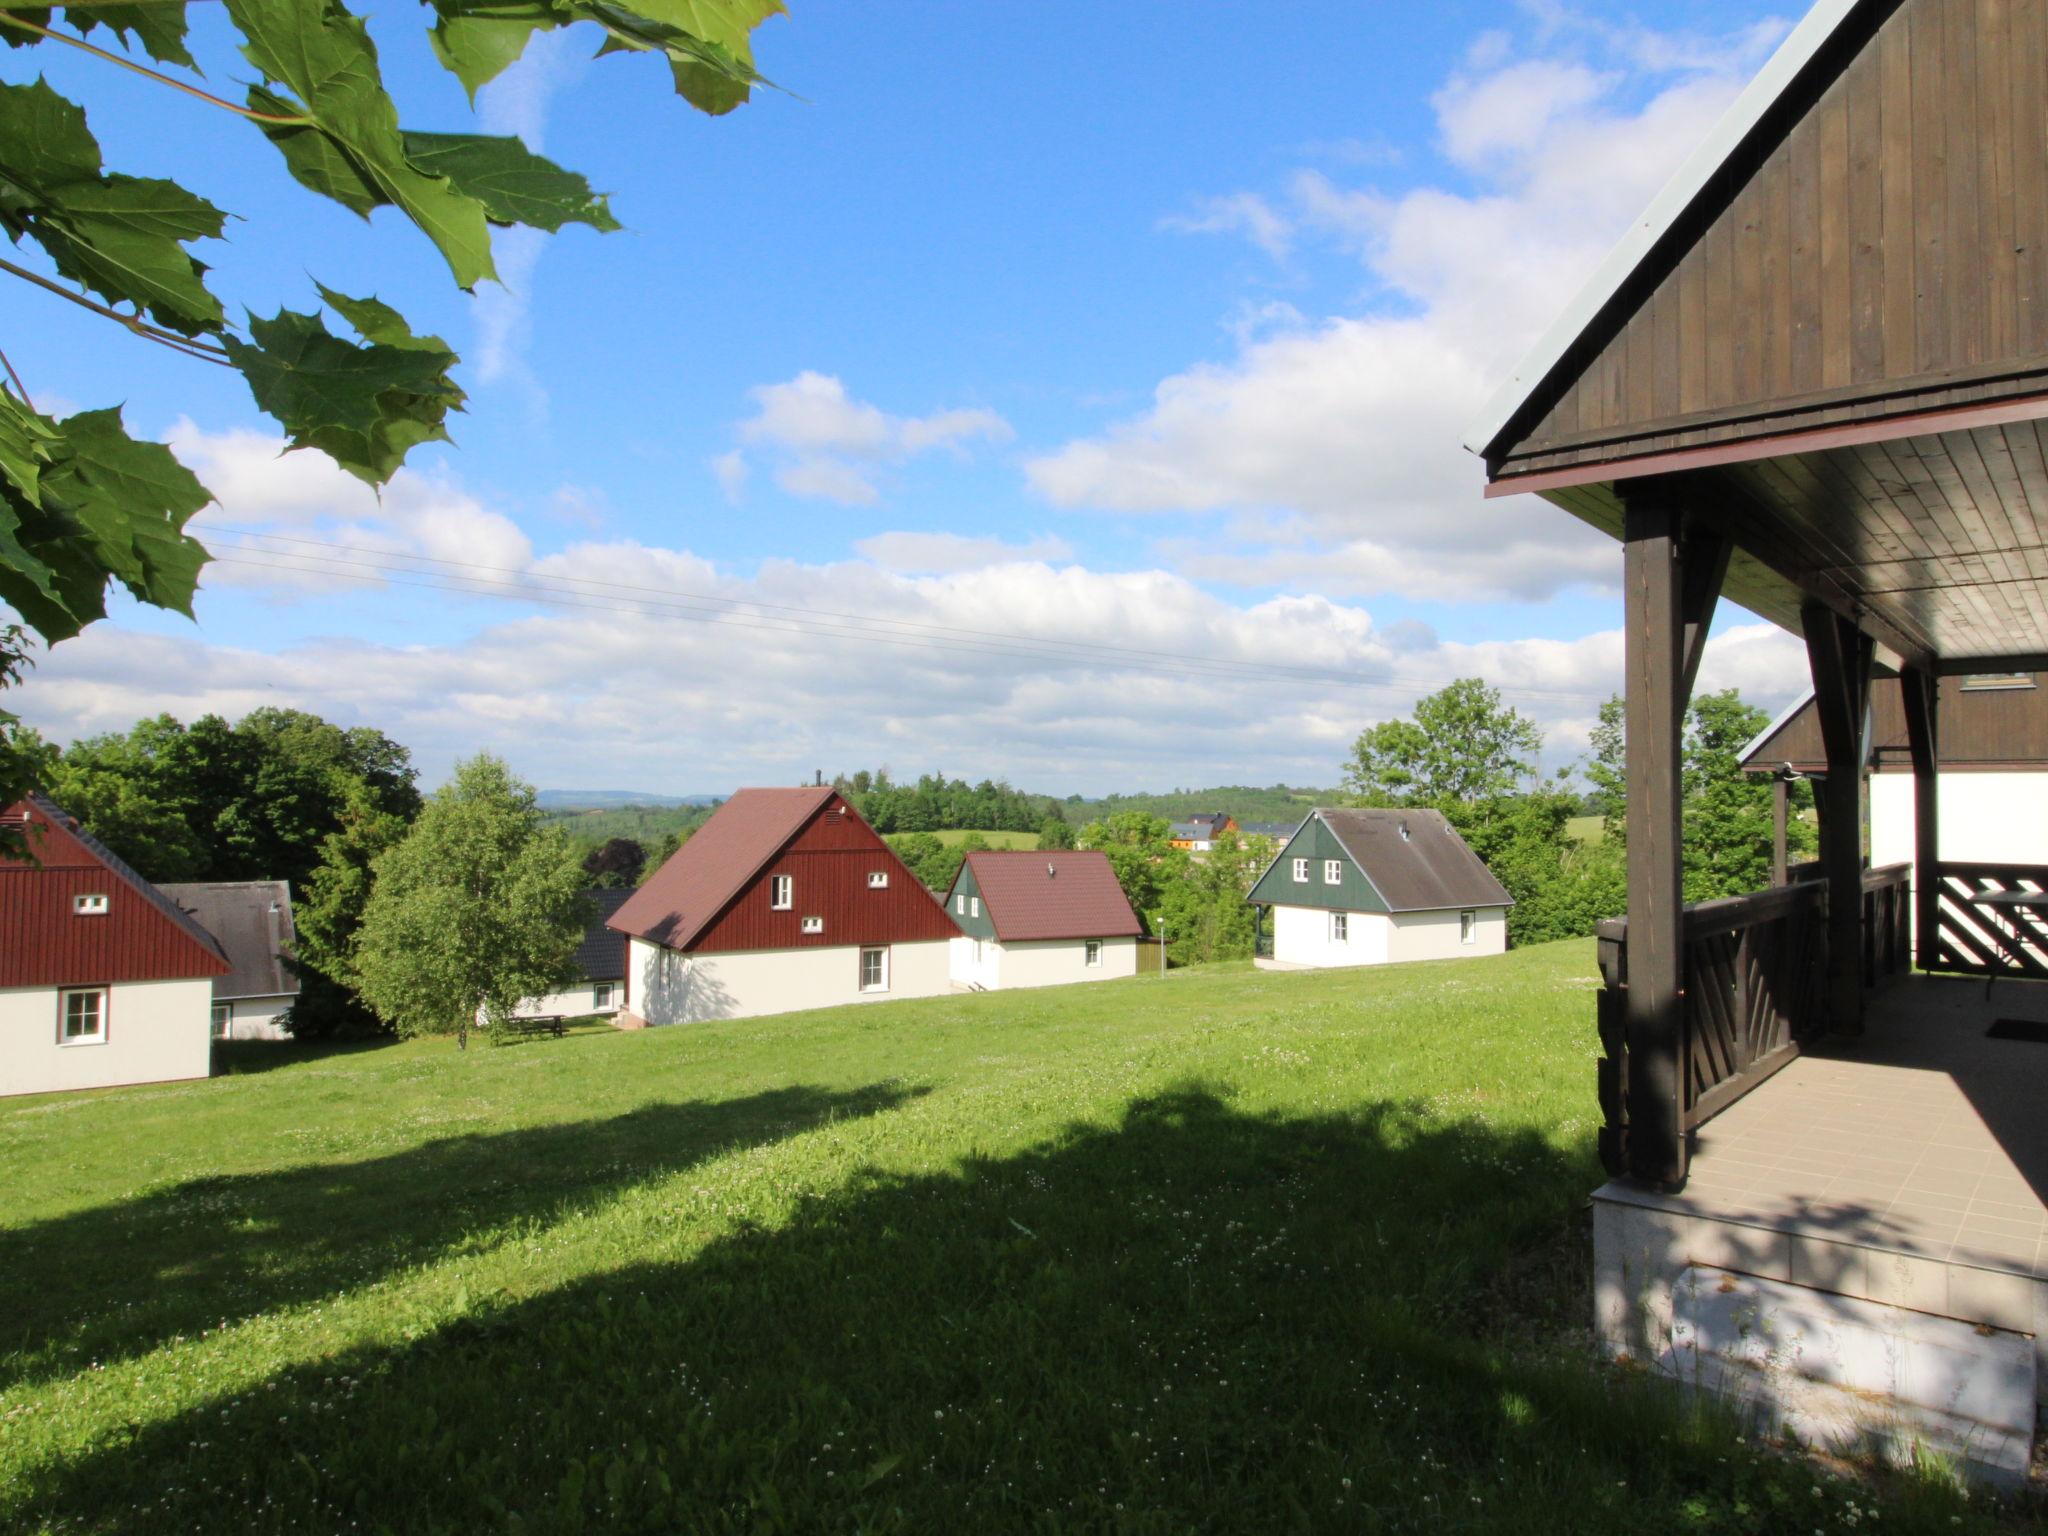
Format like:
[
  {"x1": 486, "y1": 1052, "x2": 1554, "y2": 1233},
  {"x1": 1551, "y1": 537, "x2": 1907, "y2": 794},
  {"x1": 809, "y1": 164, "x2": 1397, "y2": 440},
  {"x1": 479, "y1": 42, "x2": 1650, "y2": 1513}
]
[{"x1": 1800, "y1": 602, "x2": 1876, "y2": 1034}]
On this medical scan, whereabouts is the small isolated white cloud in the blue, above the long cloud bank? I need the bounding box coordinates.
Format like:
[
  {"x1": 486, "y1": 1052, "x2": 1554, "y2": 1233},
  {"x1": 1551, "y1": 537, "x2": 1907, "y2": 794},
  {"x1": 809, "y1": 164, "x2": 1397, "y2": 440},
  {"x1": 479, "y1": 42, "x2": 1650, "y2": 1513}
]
[{"x1": 729, "y1": 369, "x2": 1014, "y2": 506}]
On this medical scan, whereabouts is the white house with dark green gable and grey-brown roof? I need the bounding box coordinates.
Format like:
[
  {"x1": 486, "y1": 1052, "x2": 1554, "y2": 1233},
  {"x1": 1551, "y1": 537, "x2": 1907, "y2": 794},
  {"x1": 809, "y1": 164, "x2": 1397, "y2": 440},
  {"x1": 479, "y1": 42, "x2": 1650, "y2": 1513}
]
[{"x1": 1247, "y1": 809, "x2": 1513, "y2": 971}]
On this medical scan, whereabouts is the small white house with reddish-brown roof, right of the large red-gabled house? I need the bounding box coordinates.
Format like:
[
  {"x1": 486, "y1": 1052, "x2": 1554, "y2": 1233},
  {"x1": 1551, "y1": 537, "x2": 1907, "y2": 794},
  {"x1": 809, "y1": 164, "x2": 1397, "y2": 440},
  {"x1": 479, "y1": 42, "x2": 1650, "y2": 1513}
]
[{"x1": 946, "y1": 848, "x2": 1145, "y2": 991}]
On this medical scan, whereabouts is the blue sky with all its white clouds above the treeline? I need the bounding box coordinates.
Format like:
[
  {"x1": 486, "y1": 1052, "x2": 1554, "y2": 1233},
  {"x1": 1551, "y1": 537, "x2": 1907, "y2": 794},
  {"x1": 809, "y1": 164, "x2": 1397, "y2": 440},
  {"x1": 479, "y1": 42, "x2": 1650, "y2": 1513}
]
[{"x1": 12, "y1": 2, "x2": 1800, "y2": 793}]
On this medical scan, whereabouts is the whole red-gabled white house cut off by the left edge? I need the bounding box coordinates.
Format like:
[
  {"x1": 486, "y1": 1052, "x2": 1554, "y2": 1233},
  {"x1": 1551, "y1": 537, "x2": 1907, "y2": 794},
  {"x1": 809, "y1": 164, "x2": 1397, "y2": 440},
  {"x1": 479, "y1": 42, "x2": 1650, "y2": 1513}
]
[{"x1": 0, "y1": 795, "x2": 233, "y2": 1094}]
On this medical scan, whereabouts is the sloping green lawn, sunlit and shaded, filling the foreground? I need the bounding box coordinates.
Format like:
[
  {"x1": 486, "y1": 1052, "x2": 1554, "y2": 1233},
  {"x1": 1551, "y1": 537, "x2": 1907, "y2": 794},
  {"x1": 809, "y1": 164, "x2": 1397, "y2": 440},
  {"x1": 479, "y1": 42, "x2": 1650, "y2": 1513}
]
[{"x1": 0, "y1": 942, "x2": 2017, "y2": 1536}]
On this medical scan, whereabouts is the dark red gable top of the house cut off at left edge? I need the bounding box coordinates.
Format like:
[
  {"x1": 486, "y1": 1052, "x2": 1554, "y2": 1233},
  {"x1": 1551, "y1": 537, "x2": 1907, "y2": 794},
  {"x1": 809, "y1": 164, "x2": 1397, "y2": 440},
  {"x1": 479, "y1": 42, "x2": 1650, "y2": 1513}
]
[{"x1": 0, "y1": 795, "x2": 231, "y2": 987}]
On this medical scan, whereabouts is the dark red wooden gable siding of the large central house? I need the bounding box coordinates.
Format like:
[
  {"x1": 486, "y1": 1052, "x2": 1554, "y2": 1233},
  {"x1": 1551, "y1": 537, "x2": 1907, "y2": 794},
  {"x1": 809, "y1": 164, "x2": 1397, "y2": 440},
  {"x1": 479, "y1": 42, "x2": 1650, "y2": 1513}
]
[{"x1": 688, "y1": 795, "x2": 961, "y2": 954}]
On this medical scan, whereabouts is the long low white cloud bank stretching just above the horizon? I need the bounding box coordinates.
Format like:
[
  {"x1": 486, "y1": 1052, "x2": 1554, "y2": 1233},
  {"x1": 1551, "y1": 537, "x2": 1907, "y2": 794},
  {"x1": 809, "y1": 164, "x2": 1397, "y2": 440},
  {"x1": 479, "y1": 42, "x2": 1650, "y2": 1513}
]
[{"x1": 10, "y1": 524, "x2": 1804, "y2": 793}]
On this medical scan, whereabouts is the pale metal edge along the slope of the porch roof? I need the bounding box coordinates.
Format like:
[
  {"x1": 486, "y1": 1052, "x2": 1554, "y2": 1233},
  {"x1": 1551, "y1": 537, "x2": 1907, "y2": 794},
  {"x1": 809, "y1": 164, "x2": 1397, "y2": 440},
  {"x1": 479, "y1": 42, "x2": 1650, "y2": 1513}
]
[{"x1": 1464, "y1": 0, "x2": 1866, "y2": 457}]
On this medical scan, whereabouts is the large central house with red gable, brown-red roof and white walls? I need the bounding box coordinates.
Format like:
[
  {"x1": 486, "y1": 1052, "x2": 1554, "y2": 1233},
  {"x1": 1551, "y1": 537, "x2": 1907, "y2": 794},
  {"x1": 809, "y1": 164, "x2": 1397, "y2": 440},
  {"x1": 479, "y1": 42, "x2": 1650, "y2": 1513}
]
[{"x1": 608, "y1": 784, "x2": 961, "y2": 1024}]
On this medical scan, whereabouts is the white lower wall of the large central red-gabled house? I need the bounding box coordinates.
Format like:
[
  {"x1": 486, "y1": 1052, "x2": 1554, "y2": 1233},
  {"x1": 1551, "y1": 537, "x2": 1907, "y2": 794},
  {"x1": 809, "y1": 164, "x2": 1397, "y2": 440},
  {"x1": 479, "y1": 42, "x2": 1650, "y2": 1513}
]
[{"x1": 627, "y1": 938, "x2": 952, "y2": 1024}]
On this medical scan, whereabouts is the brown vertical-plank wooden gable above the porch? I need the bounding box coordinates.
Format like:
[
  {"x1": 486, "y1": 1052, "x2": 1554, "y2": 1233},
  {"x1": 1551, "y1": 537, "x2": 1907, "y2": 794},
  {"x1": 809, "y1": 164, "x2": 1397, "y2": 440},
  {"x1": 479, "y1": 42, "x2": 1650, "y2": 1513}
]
[{"x1": 1485, "y1": 0, "x2": 2048, "y2": 489}]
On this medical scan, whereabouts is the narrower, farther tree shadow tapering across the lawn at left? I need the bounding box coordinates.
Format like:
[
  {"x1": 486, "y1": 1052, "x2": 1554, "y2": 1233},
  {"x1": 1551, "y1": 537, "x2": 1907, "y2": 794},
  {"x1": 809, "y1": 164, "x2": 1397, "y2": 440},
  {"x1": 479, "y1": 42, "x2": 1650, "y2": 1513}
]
[{"x1": 0, "y1": 1085, "x2": 924, "y2": 1389}]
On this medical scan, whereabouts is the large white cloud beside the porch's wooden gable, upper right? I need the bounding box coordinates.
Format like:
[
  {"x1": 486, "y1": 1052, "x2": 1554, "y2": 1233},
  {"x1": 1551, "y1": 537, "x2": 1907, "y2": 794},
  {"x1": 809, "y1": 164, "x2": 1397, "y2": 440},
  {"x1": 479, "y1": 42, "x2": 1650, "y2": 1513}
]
[{"x1": 1026, "y1": 10, "x2": 1767, "y2": 600}]
